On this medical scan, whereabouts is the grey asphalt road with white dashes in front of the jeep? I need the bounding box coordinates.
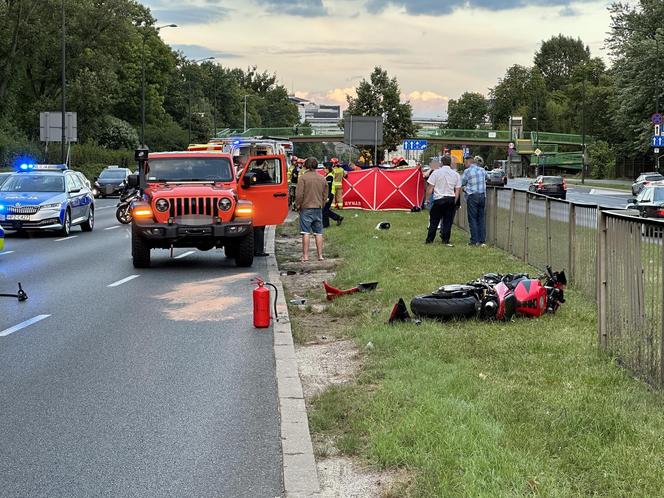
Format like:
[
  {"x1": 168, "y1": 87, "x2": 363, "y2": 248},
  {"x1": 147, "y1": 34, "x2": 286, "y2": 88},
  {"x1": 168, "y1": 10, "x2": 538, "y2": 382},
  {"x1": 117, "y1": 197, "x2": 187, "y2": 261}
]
[{"x1": 0, "y1": 199, "x2": 283, "y2": 497}]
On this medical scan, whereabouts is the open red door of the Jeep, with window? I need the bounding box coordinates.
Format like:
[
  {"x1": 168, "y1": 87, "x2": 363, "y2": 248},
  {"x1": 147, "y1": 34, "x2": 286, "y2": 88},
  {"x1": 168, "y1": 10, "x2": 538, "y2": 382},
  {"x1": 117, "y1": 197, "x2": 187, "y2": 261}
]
[{"x1": 238, "y1": 155, "x2": 288, "y2": 227}]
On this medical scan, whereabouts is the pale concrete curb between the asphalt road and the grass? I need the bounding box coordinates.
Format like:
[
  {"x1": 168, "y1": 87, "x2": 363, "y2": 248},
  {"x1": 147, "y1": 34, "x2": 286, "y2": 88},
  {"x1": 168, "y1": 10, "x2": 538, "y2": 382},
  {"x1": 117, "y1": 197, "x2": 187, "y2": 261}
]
[{"x1": 265, "y1": 226, "x2": 320, "y2": 498}]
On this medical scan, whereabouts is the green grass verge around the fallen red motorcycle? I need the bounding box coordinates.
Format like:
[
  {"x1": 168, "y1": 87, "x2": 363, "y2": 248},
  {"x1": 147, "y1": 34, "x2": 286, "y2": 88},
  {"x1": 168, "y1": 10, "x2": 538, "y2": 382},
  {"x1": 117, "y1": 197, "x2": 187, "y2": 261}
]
[{"x1": 294, "y1": 208, "x2": 664, "y2": 497}]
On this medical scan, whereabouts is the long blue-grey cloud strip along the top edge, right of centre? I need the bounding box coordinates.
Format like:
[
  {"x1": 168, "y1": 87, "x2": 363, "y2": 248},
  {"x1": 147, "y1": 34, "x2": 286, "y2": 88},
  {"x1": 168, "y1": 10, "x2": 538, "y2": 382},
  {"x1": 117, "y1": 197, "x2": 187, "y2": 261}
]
[{"x1": 366, "y1": 0, "x2": 594, "y2": 16}]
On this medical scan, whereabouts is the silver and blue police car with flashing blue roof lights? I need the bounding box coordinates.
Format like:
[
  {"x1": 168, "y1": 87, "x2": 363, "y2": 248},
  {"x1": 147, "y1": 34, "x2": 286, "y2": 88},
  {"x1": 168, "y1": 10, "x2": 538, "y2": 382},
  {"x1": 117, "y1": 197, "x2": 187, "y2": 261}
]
[{"x1": 0, "y1": 164, "x2": 95, "y2": 236}]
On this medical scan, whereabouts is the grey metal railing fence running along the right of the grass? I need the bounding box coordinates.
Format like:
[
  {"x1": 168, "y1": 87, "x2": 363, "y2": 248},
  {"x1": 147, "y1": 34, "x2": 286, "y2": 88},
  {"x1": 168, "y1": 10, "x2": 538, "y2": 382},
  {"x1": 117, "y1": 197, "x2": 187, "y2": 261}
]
[{"x1": 456, "y1": 188, "x2": 664, "y2": 388}]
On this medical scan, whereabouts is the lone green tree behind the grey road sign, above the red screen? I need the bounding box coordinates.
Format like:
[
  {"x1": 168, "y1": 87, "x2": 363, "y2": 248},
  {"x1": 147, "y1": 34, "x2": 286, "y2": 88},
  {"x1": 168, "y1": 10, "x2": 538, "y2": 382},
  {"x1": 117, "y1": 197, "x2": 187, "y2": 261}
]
[{"x1": 347, "y1": 66, "x2": 417, "y2": 151}]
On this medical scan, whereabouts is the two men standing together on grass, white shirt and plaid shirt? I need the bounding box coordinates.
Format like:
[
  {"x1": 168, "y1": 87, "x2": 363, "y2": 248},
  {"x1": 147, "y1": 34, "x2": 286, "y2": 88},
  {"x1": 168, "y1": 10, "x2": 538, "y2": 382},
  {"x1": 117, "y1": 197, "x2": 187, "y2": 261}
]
[{"x1": 425, "y1": 155, "x2": 486, "y2": 247}]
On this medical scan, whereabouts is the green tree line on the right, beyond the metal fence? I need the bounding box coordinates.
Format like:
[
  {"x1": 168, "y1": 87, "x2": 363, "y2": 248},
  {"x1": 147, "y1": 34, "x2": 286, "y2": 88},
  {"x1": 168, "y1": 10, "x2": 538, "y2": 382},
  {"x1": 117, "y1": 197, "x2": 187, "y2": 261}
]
[{"x1": 447, "y1": 0, "x2": 664, "y2": 176}]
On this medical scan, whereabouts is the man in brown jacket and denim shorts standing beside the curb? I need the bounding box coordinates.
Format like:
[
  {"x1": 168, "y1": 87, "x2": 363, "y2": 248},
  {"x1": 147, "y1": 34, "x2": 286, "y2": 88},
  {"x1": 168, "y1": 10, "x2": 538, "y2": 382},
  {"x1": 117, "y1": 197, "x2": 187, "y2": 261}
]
[{"x1": 295, "y1": 157, "x2": 328, "y2": 262}]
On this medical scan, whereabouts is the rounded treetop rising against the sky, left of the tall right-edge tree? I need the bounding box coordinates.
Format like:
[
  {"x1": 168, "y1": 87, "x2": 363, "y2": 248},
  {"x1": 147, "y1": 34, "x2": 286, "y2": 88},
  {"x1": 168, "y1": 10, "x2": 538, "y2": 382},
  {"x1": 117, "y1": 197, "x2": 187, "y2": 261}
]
[{"x1": 534, "y1": 35, "x2": 590, "y2": 92}]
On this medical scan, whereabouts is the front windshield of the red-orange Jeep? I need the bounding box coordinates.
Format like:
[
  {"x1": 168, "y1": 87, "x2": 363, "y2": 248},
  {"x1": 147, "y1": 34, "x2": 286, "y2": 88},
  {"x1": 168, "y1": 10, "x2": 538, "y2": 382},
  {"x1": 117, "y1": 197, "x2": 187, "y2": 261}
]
[{"x1": 147, "y1": 157, "x2": 233, "y2": 182}]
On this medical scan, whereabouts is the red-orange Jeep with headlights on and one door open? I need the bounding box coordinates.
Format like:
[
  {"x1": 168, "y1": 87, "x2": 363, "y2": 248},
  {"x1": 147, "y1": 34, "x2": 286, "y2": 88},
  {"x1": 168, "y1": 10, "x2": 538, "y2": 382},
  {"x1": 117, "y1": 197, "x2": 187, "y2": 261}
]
[{"x1": 129, "y1": 149, "x2": 288, "y2": 268}]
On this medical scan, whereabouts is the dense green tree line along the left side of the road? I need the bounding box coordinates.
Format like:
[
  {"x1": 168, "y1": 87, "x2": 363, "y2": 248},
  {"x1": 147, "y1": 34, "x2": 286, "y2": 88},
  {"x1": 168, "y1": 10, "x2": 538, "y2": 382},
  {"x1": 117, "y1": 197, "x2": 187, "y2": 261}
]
[{"x1": 0, "y1": 0, "x2": 299, "y2": 167}]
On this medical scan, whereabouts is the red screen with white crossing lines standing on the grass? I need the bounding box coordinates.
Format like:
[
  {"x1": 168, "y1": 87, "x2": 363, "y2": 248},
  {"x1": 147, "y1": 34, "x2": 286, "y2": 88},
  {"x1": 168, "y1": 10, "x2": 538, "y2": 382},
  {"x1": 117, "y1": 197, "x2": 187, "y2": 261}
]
[{"x1": 343, "y1": 168, "x2": 424, "y2": 211}]
